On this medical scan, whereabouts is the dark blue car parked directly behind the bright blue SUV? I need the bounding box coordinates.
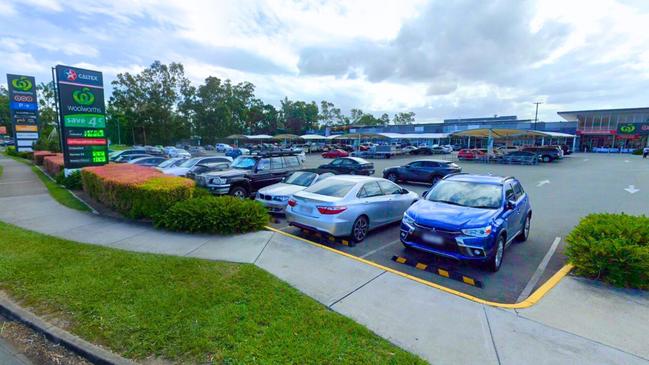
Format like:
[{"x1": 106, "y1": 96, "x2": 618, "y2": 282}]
[{"x1": 383, "y1": 160, "x2": 462, "y2": 184}]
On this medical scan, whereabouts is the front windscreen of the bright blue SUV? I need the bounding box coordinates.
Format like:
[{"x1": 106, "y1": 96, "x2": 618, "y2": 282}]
[{"x1": 426, "y1": 180, "x2": 502, "y2": 209}]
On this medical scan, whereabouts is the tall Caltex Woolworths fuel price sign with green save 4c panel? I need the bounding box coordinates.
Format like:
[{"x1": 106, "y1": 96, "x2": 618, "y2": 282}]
[{"x1": 56, "y1": 65, "x2": 108, "y2": 169}]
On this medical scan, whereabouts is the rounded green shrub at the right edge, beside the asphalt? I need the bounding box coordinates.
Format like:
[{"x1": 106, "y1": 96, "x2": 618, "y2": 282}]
[{"x1": 565, "y1": 214, "x2": 649, "y2": 289}]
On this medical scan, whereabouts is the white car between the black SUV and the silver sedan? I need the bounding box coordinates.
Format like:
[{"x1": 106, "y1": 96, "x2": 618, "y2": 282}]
[{"x1": 255, "y1": 169, "x2": 334, "y2": 213}]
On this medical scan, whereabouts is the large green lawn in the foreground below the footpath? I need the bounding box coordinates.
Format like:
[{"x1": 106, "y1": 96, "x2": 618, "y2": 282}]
[{"x1": 0, "y1": 222, "x2": 424, "y2": 364}]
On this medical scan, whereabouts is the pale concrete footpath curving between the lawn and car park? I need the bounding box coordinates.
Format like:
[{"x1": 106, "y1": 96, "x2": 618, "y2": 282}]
[{"x1": 0, "y1": 156, "x2": 649, "y2": 364}]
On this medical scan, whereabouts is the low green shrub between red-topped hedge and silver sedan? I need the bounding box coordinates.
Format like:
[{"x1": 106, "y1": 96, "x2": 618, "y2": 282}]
[{"x1": 154, "y1": 196, "x2": 270, "y2": 234}]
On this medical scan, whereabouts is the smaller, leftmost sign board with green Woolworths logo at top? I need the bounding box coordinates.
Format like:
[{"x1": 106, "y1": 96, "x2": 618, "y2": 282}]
[{"x1": 6, "y1": 74, "x2": 38, "y2": 152}]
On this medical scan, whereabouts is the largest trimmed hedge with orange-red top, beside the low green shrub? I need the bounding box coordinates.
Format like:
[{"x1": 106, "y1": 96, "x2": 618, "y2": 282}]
[{"x1": 81, "y1": 164, "x2": 194, "y2": 219}]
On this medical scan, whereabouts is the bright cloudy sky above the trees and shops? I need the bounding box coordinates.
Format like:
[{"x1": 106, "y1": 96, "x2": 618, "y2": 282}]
[{"x1": 0, "y1": 0, "x2": 649, "y2": 122}]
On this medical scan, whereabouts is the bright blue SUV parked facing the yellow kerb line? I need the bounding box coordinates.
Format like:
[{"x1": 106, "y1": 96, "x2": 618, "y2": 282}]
[{"x1": 400, "y1": 174, "x2": 532, "y2": 272}]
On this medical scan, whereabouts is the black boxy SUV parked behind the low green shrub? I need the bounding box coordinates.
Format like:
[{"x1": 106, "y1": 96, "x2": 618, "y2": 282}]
[{"x1": 196, "y1": 152, "x2": 302, "y2": 198}]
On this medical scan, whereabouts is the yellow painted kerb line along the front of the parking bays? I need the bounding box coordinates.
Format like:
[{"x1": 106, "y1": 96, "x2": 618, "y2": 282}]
[{"x1": 265, "y1": 226, "x2": 573, "y2": 309}]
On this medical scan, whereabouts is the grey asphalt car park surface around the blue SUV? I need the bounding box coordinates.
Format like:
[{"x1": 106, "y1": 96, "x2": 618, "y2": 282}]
[{"x1": 272, "y1": 154, "x2": 649, "y2": 303}]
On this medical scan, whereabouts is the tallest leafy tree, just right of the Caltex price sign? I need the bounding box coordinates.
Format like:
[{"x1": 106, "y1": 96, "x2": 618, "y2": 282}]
[{"x1": 109, "y1": 61, "x2": 191, "y2": 145}]
